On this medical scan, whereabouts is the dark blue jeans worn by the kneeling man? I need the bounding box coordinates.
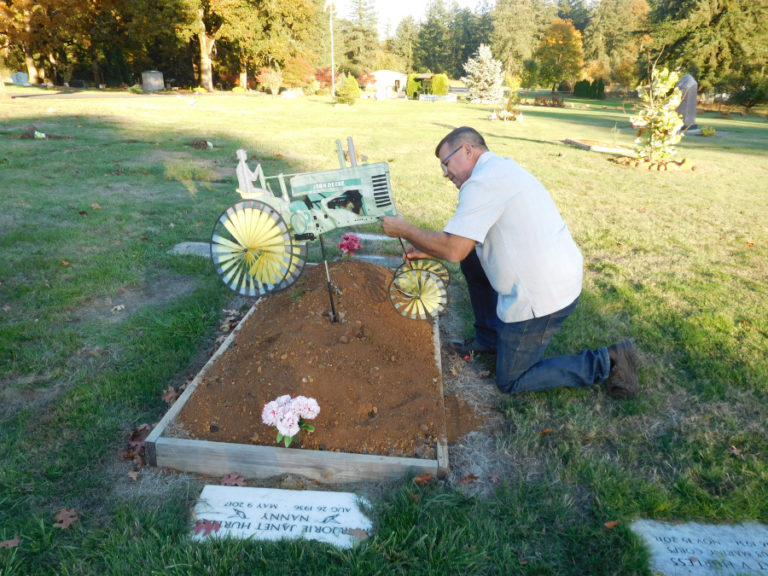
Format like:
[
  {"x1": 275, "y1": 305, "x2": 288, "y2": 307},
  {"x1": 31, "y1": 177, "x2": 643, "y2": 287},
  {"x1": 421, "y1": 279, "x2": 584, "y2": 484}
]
[{"x1": 461, "y1": 250, "x2": 611, "y2": 394}]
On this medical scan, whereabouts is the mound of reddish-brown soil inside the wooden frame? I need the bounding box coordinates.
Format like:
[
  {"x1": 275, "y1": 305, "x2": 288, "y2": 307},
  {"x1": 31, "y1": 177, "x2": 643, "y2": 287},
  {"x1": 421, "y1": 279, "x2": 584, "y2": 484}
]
[{"x1": 174, "y1": 260, "x2": 450, "y2": 459}]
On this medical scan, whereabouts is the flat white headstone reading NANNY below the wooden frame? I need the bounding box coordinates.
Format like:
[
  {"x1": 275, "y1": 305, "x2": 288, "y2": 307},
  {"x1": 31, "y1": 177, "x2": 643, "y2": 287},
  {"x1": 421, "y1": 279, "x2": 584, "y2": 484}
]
[{"x1": 193, "y1": 485, "x2": 373, "y2": 548}]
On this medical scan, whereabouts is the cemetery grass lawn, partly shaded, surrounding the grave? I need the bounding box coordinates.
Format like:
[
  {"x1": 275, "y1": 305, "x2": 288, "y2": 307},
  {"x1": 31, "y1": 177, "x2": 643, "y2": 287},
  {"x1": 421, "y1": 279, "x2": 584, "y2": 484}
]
[{"x1": 0, "y1": 88, "x2": 768, "y2": 576}]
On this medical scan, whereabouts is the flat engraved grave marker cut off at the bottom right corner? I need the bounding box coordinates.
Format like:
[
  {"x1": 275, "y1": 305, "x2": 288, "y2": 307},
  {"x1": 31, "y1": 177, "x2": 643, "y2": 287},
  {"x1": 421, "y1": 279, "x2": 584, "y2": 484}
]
[{"x1": 632, "y1": 520, "x2": 768, "y2": 576}]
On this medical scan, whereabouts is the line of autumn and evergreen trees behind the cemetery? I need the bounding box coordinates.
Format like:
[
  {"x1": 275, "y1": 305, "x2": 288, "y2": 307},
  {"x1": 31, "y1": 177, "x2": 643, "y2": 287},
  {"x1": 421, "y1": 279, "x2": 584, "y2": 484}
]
[{"x1": 0, "y1": 0, "x2": 768, "y2": 98}]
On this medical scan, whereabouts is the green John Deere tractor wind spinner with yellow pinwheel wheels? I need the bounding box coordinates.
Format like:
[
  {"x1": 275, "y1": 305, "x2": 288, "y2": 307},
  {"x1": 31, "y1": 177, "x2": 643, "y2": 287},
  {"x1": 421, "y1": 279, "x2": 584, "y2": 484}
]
[{"x1": 211, "y1": 138, "x2": 450, "y2": 321}]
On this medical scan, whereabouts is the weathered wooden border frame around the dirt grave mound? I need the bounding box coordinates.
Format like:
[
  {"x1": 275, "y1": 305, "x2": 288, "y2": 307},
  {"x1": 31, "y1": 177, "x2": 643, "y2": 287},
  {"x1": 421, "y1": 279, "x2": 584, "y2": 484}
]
[{"x1": 144, "y1": 301, "x2": 448, "y2": 483}]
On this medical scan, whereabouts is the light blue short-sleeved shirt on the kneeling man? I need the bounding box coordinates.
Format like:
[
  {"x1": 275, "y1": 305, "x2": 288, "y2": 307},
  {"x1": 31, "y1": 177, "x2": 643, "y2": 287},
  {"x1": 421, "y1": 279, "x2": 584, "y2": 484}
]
[{"x1": 444, "y1": 152, "x2": 584, "y2": 322}]
